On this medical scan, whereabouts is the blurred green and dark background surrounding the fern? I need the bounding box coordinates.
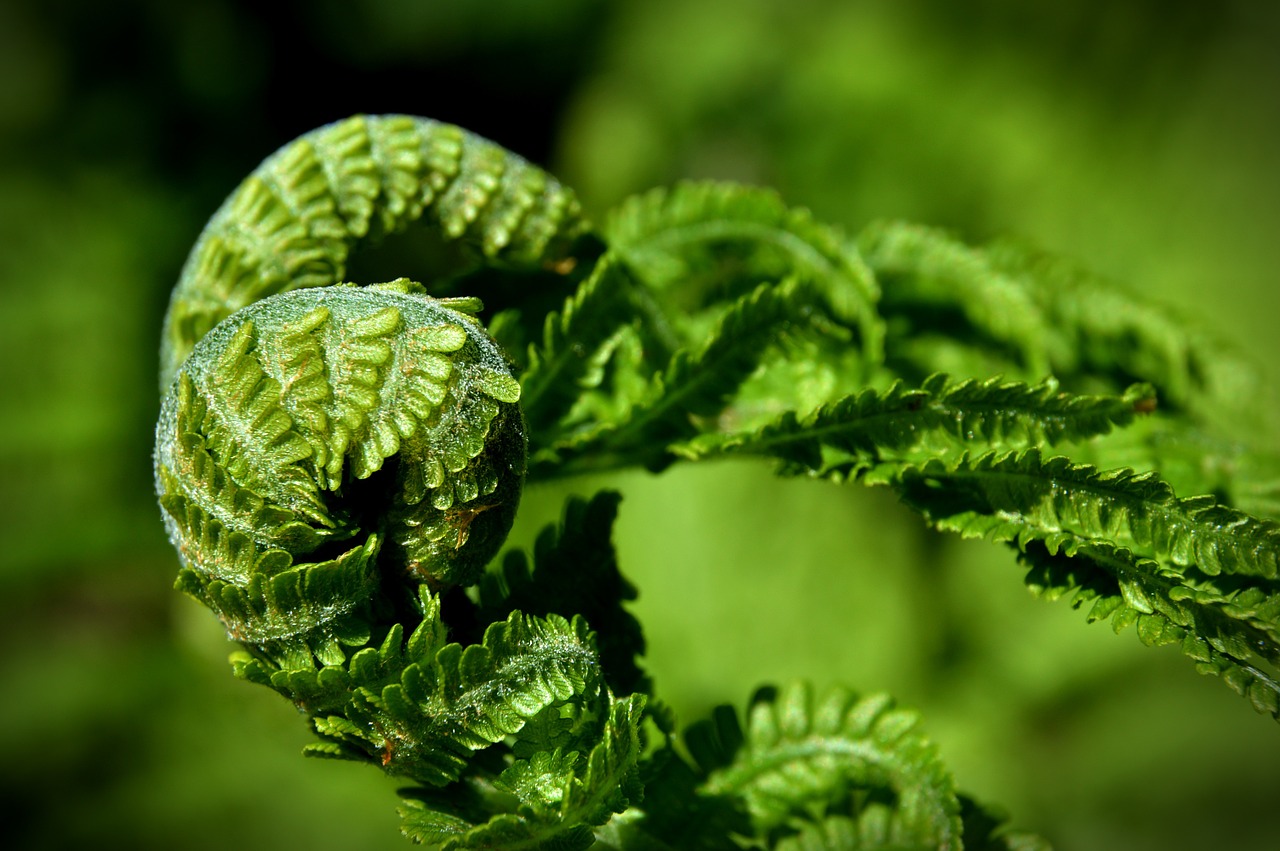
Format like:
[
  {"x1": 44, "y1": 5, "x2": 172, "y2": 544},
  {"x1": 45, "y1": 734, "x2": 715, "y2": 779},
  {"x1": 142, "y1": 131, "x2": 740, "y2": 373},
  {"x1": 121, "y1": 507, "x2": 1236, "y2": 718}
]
[{"x1": 0, "y1": 0, "x2": 1280, "y2": 850}]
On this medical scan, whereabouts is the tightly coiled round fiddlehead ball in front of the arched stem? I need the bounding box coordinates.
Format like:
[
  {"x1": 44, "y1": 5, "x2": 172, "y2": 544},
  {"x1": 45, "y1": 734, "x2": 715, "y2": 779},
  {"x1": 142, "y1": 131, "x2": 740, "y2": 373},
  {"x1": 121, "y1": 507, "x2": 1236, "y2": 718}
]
[{"x1": 156, "y1": 287, "x2": 525, "y2": 616}]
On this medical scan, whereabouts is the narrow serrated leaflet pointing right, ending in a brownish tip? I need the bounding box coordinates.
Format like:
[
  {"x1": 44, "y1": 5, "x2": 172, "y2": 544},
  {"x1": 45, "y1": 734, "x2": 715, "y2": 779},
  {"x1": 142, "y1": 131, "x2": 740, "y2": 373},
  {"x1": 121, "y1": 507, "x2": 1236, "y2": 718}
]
[{"x1": 671, "y1": 375, "x2": 1153, "y2": 472}]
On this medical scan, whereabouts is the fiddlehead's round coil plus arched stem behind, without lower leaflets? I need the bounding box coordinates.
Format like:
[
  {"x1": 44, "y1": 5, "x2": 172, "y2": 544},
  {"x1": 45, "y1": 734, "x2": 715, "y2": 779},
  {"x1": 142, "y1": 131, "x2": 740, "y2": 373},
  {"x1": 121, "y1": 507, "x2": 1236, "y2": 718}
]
[{"x1": 156, "y1": 115, "x2": 585, "y2": 644}]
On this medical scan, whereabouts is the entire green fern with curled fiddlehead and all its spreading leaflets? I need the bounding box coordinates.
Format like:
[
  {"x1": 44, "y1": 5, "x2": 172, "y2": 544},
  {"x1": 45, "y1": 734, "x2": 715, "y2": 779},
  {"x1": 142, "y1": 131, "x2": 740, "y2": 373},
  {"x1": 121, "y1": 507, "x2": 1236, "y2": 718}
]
[{"x1": 155, "y1": 116, "x2": 1280, "y2": 848}]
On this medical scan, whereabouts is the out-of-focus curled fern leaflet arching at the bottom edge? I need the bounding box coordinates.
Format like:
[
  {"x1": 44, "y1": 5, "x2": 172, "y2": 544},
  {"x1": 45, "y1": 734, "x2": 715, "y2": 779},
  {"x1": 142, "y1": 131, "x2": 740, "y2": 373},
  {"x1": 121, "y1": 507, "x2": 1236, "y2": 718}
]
[{"x1": 690, "y1": 685, "x2": 961, "y2": 848}]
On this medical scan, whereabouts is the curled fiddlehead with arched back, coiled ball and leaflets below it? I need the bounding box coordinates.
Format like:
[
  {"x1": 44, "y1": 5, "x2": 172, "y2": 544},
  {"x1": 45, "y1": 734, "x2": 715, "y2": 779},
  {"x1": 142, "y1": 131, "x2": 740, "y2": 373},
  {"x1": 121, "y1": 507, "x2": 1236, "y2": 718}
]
[{"x1": 155, "y1": 116, "x2": 644, "y2": 847}]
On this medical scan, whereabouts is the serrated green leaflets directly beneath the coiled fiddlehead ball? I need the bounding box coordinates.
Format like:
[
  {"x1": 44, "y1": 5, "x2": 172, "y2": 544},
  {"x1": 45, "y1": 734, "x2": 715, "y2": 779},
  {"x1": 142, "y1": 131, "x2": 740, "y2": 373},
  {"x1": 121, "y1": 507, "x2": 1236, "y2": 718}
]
[{"x1": 237, "y1": 590, "x2": 600, "y2": 787}]
